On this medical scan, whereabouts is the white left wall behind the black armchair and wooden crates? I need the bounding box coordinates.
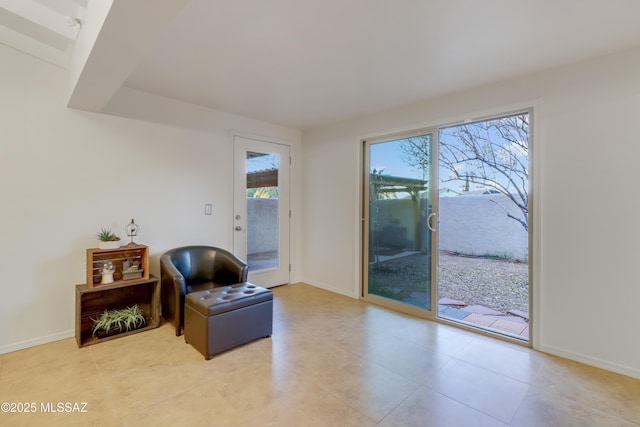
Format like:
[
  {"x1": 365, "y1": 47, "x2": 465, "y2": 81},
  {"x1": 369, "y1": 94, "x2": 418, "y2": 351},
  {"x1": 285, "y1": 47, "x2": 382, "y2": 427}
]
[{"x1": 0, "y1": 45, "x2": 300, "y2": 353}]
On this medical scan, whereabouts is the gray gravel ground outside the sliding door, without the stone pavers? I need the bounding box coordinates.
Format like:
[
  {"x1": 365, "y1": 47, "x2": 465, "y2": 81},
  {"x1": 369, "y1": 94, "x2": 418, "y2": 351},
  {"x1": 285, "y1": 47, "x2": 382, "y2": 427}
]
[{"x1": 375, "y1": 252, "x2": 529, "y2": 313}]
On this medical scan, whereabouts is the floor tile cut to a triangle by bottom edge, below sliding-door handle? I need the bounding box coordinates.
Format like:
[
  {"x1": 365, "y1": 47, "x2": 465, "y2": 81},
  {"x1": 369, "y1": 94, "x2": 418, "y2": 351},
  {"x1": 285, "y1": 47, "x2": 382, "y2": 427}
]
[{"x1": 379, "y1": 387, "x2": 507, "y2": 427}]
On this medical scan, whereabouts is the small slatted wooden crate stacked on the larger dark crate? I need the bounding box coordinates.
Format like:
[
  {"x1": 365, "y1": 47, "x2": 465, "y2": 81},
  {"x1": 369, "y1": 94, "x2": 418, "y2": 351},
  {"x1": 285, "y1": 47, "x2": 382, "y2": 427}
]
[{"x1": 87, "y1": 245, "x2": 149, "y2": 287}]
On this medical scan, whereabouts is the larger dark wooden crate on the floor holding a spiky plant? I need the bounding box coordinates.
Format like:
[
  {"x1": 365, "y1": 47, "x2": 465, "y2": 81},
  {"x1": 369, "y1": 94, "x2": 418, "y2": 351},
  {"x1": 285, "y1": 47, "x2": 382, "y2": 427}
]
[{"x1": 76, "y1": 275, "x2": 160, "y2": 347}]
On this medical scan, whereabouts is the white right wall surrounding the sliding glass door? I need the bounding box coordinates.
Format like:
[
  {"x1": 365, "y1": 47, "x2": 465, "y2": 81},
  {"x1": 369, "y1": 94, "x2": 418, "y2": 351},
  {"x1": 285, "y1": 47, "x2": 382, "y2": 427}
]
[{"x1": 302, "y1": 49, "x2": 640, "y2": 377}]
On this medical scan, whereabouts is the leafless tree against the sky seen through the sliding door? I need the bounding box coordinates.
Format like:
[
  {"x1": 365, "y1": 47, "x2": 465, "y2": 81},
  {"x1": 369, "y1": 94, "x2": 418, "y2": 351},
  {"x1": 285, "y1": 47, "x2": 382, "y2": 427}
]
[{"x1": 402, "y1": 113, "x2": 529, "y2": 230}]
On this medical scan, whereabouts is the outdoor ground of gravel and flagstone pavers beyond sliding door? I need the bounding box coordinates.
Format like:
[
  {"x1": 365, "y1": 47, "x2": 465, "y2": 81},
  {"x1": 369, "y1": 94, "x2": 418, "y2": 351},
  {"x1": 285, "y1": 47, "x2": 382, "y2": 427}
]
[{"x1": 369, "y1": 252, "x2": 529, "y2": 340}]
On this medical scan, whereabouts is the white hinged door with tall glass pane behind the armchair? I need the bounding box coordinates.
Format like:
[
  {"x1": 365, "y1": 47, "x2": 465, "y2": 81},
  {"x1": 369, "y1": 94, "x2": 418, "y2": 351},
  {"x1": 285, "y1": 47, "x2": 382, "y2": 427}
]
[{"x1": 233, "y1": 135, "x2": 290, "y2": 287}]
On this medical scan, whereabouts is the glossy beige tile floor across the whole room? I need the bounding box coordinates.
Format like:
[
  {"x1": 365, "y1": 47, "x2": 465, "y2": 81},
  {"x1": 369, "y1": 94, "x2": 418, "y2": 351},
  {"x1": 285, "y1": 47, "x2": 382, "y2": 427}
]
[{"x1": 0, "y1": 284, "x2": 640, "y2": 427}]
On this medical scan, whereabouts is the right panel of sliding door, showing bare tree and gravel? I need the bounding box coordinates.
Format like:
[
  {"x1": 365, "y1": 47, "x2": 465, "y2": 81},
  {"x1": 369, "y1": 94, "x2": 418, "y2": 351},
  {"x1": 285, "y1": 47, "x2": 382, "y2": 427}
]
[{"x1": 437, "y1": 112, "x2": 530, "y2": 341}]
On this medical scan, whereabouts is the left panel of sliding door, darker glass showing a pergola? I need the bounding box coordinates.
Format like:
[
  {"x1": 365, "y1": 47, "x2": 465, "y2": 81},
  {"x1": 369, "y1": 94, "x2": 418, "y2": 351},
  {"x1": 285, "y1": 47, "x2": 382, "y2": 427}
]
[{"x1": 363, "y1": 133, "x2": 436, "y2": 311}]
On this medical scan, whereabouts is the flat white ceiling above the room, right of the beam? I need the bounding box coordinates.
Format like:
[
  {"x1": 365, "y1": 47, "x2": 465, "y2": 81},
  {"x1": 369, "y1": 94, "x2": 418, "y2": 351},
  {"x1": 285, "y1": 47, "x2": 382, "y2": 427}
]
[{"x1": 0, "y1": 0, "x2": 640, "y2": 129}]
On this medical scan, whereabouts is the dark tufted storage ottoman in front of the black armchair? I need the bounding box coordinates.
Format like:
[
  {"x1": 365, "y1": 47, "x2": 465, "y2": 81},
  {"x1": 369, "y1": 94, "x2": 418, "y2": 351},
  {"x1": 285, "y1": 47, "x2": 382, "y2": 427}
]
[{"x1": 184, "y1": 282, "x2": 273, "y2": 359}]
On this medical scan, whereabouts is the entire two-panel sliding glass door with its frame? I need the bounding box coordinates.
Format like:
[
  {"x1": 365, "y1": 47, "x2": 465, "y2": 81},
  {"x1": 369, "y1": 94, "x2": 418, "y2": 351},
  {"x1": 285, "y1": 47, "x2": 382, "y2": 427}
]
[{"x1": 362, "y1": 111, "x2": 531, "y2": 341}]
